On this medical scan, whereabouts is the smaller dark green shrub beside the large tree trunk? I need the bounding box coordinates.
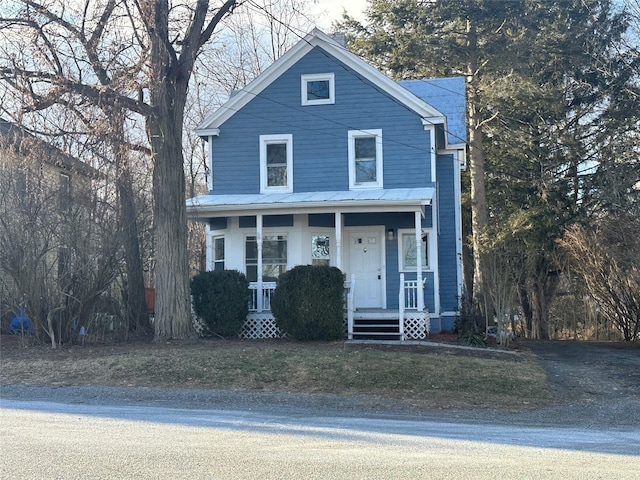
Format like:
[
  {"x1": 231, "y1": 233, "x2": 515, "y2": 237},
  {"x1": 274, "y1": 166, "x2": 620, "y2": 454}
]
[{"x1": 191, "y1": 270, "x2": 250, "y2": 337}]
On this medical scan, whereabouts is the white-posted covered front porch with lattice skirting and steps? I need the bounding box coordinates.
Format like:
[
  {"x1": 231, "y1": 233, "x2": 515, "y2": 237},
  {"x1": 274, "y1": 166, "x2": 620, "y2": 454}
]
[{"x1": 188, "y1": 187, "x2": 438, "y2": 340}]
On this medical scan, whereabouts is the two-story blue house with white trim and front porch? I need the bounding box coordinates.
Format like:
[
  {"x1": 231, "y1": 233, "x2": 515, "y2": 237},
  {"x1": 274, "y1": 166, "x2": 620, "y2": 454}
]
[{"x1": 188, "y1": 30, "x2": 466, "y2": 339}]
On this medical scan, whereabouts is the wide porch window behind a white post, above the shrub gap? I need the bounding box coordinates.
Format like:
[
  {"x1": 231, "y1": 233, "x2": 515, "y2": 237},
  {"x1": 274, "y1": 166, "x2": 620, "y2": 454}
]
[{"x1": 245, "y1": 235, "x2": 287, "y2": 282}]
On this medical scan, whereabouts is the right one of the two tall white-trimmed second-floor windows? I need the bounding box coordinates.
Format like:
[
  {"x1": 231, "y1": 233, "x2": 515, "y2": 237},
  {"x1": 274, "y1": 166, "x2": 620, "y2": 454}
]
[{"x1": 349, "y1": 130, "x2": 382, "y2": 189}]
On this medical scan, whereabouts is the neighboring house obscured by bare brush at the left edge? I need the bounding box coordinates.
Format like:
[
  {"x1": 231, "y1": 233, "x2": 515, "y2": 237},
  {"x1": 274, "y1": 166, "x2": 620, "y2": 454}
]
[{"x1": 0, "y1": 118, "x2": 97, "y2": 316}]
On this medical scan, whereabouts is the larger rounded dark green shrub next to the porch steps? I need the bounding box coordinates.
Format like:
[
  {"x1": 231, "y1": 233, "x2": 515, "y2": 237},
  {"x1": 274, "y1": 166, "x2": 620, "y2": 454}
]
[{"x1": 271, "y1": 265, "x2": 345, "y2": 340}]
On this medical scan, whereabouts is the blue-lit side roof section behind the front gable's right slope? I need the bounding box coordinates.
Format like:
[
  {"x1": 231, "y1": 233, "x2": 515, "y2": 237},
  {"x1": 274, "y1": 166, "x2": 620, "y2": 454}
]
[{"x1": 398, "y1": 77, "x2": 467, "y2": 145}]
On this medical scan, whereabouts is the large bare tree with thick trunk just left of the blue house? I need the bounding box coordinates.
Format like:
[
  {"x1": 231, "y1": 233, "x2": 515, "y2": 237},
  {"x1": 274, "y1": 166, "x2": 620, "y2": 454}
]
[{"x1": 0, "y1": 0, "x2": 240, "y2": 340}]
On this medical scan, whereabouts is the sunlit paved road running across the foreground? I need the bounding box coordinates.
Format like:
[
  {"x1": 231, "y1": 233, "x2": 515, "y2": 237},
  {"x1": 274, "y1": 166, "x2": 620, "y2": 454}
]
[{"x1": 0, "y1": 399, "x2": 640, "y2": 480}]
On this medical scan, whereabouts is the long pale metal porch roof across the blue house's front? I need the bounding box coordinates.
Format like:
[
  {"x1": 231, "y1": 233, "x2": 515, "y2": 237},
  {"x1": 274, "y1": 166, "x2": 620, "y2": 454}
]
[{"x1": 187, "y1": 187, "x2": 435, "y2": 219}]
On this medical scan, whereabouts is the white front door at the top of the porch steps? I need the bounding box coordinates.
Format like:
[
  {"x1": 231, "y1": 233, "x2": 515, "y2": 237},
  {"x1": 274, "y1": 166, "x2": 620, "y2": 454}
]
[{"x1": 348, "y1": 228, "x2": 386, "y2": 308}]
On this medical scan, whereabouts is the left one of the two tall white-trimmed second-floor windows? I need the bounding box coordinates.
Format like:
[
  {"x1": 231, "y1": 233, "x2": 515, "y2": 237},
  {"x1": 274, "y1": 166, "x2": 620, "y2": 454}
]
[{"x1": 260, "y1": 134, "x2": 293, "y2": 193}]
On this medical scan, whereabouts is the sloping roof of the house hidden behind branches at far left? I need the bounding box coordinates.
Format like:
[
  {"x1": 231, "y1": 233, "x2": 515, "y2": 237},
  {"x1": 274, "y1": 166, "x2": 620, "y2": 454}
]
[{"x1": 0, "y1": 118, "x2": 99, "y2": 177}]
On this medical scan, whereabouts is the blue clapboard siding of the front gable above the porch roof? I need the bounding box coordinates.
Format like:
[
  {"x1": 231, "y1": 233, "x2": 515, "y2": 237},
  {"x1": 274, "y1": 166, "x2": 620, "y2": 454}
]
[{"x1": 211, "y1": 47, "x2": 431, "y2": 195}]
